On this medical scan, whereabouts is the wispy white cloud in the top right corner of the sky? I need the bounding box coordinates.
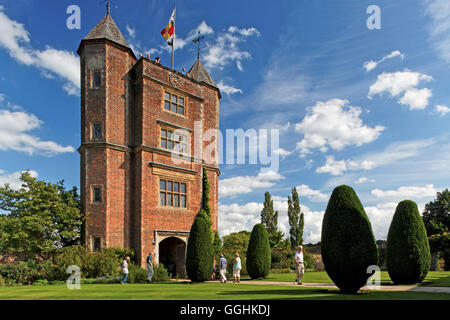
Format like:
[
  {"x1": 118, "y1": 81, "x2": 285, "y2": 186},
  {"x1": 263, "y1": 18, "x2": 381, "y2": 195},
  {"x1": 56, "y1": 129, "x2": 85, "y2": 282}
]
[{"x1": 425, "y1": 0, "x2": 450, "y2": 62}]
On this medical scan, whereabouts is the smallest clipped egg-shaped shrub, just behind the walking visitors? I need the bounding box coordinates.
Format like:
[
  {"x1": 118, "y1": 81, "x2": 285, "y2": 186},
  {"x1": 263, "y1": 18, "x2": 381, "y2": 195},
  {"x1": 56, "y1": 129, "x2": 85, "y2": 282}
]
[{"x1": 246, "y1": 223, "x2": 271, "y2": 279}]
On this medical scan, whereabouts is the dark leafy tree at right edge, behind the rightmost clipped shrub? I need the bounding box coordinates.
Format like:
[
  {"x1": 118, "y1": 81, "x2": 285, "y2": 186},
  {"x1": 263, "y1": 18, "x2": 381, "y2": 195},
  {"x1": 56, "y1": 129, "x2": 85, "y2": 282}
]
[{"x1": 423, "y1": 189, "x2": 450, "y2": 236}]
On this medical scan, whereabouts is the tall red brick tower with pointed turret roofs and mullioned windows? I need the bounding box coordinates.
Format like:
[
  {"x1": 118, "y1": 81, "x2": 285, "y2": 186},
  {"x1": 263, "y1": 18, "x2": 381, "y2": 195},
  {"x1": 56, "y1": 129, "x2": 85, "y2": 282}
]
[{"x1": 78, "y1": 14, "x2": 220, "y2": 276}]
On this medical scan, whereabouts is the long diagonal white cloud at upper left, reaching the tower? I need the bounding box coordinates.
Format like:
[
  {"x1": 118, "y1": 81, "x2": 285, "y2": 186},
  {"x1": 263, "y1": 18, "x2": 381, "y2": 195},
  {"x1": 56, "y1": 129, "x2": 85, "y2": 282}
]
[{"x1": 0, "y1": 6, "x2": 80, "y2": 95}]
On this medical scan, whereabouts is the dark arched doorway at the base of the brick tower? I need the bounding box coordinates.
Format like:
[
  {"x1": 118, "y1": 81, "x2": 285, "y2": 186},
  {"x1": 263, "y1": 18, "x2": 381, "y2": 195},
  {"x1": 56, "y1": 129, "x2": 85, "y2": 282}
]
[{"x1": 158, "y1": 237, "x2": 186, "y2": 278}]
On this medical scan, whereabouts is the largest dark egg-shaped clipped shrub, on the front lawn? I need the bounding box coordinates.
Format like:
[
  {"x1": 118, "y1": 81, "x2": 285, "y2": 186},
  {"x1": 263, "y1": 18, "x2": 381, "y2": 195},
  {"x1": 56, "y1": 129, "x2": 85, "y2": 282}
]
[{"x1": 321, "y1": 185, "x2": 378, "y2": 293}]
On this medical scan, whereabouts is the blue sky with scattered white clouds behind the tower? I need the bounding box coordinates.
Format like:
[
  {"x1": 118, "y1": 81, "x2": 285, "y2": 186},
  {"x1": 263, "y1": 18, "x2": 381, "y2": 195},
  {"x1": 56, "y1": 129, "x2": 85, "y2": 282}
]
[{"x1": 0, "y1": 0, "x2": 450, "y2": 242}]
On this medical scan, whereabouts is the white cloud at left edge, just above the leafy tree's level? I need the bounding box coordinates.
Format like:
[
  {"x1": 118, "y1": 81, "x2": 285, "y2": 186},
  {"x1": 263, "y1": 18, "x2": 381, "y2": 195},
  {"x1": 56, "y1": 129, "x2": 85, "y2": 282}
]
[{"x1": 0, "y1": 110, "x2": 74, "y2": 156}]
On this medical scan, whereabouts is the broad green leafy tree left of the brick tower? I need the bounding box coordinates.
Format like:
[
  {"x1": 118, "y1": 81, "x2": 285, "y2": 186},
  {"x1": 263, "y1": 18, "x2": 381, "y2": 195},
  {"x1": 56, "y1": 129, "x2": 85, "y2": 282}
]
[{"x1": 0, "y1": 171, "x2": 83, "y2": 258}]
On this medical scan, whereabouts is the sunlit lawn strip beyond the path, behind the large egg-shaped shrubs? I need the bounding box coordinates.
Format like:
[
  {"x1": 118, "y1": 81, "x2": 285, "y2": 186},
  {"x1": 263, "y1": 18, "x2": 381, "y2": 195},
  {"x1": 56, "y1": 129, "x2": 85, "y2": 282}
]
[{"x1": 246, "y1": 271, "x2": 450, "y2": 287}]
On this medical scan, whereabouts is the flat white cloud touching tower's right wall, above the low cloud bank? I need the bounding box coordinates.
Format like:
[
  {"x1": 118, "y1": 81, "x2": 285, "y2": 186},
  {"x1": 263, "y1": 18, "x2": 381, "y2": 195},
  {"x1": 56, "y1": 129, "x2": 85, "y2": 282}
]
[{"x1": 219, "y1": 170, "x2": 284, "y2": 197}]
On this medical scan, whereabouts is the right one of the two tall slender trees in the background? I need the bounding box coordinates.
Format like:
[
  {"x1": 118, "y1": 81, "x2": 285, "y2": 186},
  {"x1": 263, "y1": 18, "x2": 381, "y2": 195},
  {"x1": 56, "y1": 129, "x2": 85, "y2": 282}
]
[{"x1": 288, "y1": 187, "x2": 305, "y2": 249}]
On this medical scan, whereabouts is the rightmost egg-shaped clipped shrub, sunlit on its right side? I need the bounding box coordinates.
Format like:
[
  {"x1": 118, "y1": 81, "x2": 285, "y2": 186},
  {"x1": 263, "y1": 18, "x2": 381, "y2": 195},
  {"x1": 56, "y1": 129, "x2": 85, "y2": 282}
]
[{"x1": 386, "y1": 200, "x2": 431, "y2": 284}]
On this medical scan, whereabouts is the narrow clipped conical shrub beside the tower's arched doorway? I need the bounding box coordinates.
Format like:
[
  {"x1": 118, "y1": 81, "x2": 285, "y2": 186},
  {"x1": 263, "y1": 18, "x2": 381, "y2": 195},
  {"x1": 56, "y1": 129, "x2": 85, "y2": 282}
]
[{"x1": 186, "y1": 210, "x2": 213, "y2": 282}]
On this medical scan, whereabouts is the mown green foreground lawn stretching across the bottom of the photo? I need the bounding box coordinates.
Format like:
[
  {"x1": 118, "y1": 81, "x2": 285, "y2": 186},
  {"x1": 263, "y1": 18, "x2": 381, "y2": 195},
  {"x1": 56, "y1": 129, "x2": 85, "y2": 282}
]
[{"x1": 0, "y1": 282, "x2": 450, "y2": 300}]
